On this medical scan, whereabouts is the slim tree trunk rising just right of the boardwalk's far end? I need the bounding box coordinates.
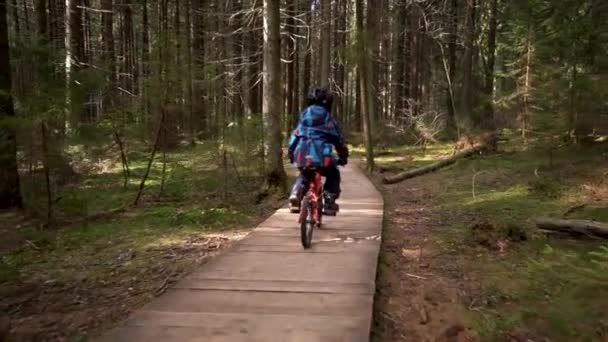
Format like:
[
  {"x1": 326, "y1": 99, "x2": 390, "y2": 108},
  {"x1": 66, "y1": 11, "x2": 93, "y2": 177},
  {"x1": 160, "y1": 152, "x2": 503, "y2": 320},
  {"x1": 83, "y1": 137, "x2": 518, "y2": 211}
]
[{"x1": 356, "y1": 0, "x2": 374, "y2": 172}]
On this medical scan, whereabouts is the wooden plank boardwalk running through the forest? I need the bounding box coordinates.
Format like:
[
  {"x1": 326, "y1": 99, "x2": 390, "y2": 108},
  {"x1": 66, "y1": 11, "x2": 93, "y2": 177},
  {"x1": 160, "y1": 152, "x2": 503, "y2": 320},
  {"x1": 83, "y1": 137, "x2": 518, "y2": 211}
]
[{"x1": 100, "y1": 166, "x2": 384, "y2": 342}]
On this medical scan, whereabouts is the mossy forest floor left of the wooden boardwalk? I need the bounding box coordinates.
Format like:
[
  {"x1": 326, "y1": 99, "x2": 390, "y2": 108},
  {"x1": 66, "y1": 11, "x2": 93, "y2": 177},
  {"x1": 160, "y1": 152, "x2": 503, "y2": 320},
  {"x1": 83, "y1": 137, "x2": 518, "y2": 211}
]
[{"x1": 0, "y1": 144, "x2": 283, "y2": 341}]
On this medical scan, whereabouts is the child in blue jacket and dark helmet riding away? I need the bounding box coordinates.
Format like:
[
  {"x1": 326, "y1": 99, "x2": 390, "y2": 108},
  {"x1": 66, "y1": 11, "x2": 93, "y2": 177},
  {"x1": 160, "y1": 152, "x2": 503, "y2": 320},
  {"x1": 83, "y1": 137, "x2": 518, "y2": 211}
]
[{"x1": 288, "y1": 87, "x2": 348, "y2": 215}]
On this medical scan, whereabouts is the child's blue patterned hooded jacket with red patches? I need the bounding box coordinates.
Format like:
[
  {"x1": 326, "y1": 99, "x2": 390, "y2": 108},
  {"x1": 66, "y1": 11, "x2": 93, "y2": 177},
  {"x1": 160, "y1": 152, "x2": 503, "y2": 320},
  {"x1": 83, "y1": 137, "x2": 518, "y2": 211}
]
[{"x1": 289, "y1": 105, "x2": 348, "y2": 169}]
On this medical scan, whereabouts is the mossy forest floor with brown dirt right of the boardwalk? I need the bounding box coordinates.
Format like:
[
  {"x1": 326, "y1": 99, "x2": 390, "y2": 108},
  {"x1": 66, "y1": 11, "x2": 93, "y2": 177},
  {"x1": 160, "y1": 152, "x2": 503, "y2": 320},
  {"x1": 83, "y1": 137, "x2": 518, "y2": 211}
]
[{"x1": 372, "y1": 141, "x2": 608, "y2": 341}]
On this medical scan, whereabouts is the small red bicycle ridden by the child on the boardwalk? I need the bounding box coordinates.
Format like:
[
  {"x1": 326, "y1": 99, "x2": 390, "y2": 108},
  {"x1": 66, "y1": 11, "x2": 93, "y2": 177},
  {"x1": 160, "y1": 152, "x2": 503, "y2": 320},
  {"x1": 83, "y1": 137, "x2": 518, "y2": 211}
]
[{"x1": 298, "y1": 170, "x2": 323, "y2": 249}]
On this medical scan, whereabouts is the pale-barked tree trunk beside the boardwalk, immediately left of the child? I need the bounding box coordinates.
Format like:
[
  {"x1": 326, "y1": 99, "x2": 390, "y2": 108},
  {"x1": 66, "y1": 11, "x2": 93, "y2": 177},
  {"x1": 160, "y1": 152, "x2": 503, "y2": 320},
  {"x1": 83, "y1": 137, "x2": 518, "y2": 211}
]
[{"x1": 263, "y1": 0, "x2": 287, "y2": 192}]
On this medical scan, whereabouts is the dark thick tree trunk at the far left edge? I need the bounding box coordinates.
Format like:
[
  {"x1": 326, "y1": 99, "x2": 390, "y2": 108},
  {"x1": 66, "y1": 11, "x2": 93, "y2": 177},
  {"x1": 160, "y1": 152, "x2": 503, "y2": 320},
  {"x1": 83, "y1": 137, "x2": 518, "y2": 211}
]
[{"x1": 0, "y1": 0, "x2": 22, "y2": 209}]
